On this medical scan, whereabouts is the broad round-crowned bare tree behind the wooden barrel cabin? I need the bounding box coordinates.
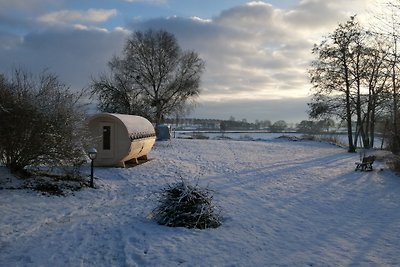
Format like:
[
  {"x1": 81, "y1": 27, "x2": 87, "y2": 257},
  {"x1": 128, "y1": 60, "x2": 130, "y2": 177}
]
[{"x1": 92, "y1": 30, "x2": 204, "y2": 124}]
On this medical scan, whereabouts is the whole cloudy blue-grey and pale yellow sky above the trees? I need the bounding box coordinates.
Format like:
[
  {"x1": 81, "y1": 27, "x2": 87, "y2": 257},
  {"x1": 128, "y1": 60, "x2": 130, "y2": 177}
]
[{"x1": 0, "y1": 0, "x2": 379, "y2": 123}]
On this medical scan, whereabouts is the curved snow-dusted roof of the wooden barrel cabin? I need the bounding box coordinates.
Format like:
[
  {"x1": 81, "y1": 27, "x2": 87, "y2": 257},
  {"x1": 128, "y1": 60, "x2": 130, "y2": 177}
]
[{"x1": 91, "y1": 113, "x2": 155, "y2": 136}]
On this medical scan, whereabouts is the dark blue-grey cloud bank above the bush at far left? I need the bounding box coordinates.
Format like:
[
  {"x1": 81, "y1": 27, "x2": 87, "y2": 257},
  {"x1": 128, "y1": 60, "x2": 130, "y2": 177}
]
[{"x1": 0, "y1": 29, "x2": 126, "y2": 90}]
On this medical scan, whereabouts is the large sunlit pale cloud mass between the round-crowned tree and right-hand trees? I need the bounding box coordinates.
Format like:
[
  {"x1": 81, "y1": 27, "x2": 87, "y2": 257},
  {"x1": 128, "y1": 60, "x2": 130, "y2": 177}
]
[{"x1": 126, "y1": 0, "x2": 378, "y2": 120}]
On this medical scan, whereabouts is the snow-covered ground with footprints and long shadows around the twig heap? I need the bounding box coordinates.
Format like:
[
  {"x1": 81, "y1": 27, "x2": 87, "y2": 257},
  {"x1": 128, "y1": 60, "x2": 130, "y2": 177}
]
[{"x1": 0, "y1": 139, "x2": 400, "y2": 266}]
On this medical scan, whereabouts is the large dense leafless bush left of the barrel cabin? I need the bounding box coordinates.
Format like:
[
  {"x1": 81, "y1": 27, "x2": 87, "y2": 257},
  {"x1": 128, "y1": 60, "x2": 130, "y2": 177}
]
[{"x1": 0, "y1": 70, "x2": 88, "y2": 173}]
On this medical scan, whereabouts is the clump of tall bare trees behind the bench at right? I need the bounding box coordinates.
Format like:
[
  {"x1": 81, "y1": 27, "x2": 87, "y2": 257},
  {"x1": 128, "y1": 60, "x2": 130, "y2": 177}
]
[{"x1": 309, "y1": 14, "x2": 397, "y2": 150}]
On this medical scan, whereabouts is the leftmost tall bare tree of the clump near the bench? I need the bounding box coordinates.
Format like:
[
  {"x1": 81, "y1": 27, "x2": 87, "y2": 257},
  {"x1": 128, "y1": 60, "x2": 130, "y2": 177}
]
[{"x1": 310, "y1": 17, "x2": 362, "y2": 152}]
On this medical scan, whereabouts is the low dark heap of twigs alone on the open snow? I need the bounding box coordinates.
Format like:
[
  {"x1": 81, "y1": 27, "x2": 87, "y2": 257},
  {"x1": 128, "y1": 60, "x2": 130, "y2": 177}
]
[{"x1": 152, "y1": 180, "x2": 221, "y2": 229}]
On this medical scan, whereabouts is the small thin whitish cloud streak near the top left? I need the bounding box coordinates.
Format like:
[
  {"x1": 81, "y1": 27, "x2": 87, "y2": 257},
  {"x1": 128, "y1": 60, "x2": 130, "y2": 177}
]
[{"x1": 37, "y1": 8, "x2": 117, "y2": 25}]
